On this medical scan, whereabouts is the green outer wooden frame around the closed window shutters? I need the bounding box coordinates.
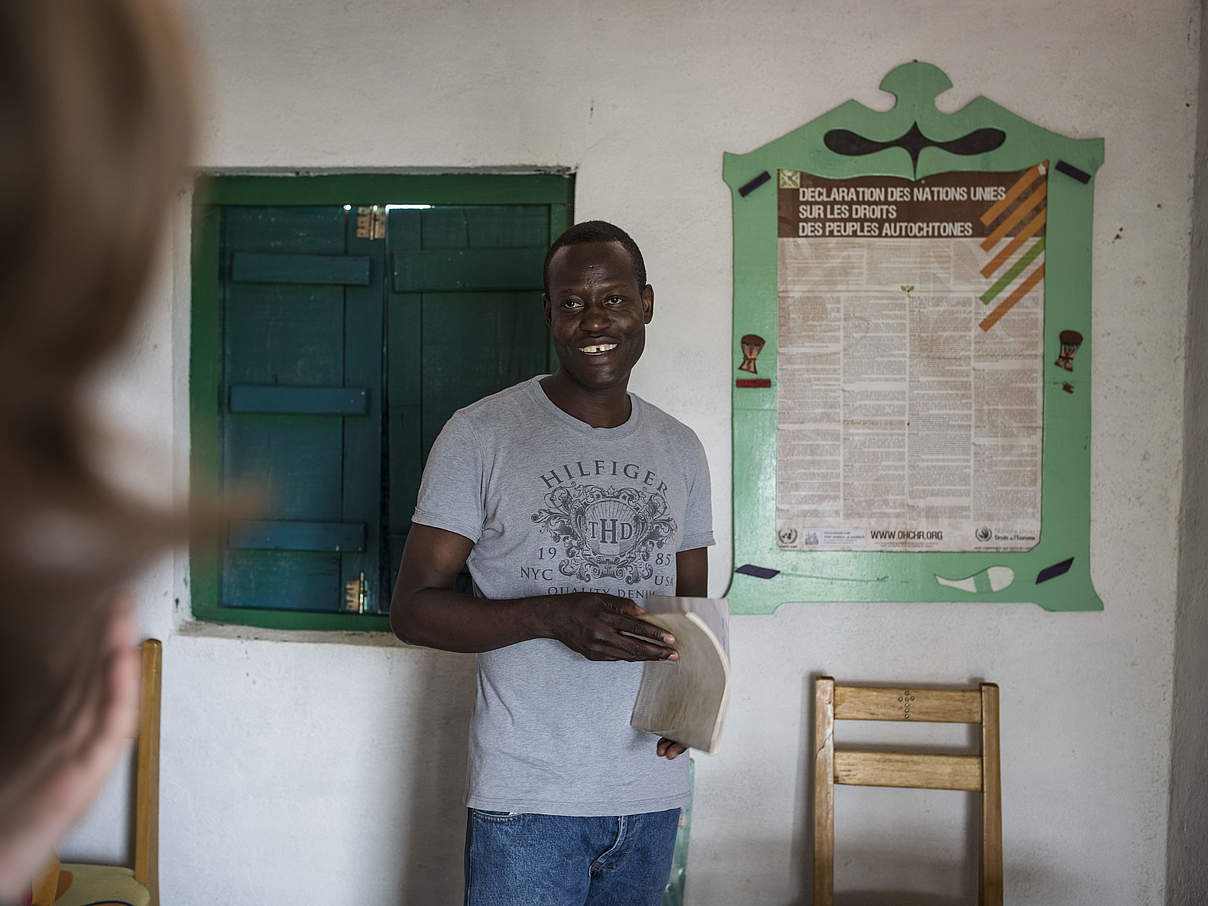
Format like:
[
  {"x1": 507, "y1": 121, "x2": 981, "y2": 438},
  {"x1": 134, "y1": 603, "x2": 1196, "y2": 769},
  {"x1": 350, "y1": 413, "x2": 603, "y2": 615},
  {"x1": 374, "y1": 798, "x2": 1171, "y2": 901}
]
[{"x1": 188, "y1": 169, "x2": 575, "y2": 632}]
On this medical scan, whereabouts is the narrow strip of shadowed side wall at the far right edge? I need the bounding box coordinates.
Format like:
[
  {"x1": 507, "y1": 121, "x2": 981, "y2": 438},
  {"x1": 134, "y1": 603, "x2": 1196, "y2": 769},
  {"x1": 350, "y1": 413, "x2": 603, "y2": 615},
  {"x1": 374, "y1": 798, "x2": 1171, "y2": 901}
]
[{"x1": 1166, "y1": 0, "x2": 1208, "y2": 906}]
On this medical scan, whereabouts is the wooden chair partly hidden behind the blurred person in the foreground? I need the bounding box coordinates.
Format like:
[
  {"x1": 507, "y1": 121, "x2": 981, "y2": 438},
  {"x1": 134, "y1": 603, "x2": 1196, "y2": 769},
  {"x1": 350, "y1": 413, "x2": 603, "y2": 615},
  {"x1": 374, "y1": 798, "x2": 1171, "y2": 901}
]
[{"x1": 33, "y1": 639, "x2": 163, "y2": 906}]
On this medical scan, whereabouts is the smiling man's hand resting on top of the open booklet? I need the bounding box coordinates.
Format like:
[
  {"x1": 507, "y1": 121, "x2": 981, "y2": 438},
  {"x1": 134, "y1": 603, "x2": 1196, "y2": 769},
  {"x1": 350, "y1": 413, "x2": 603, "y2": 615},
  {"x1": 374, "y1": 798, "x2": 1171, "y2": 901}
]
[{"x1": 530, "y1": 592, "x2": 679, "y2": 661}]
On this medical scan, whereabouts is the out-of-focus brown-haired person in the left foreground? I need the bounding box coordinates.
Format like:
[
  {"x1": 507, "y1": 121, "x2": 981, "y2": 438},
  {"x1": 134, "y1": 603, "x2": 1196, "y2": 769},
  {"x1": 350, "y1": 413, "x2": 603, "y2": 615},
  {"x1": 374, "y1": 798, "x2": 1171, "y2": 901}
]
[{"x1": 0, "y1": 0, "x2": 193, "y2": 901}]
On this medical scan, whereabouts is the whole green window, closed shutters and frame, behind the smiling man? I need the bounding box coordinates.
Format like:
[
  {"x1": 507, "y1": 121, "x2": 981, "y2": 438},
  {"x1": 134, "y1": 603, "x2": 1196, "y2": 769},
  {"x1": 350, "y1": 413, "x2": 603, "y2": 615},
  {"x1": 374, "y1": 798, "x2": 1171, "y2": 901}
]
[{"x1": 190, "y1": 174, "x2": 573, "y2": 629}]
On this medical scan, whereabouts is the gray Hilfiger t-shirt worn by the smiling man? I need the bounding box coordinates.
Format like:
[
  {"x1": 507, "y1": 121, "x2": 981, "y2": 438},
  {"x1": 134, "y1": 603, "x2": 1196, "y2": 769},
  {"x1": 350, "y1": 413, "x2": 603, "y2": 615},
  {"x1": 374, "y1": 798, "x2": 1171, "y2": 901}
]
[{"x1": 414, "y1": 377, "x2": 713, "y2": 815}]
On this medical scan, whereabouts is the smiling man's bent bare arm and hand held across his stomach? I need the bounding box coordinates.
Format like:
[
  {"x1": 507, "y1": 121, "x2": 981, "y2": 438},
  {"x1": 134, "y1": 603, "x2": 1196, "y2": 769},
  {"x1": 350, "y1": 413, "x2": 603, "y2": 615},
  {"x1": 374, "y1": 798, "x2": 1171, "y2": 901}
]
[{"x1": 390, "y1": 523, "x2": 681, "y2": 661}]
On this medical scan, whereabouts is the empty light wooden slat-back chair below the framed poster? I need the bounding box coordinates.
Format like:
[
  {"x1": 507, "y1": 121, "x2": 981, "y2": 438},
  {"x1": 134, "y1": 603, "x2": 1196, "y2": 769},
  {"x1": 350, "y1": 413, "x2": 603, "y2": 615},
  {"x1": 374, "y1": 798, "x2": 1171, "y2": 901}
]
[{"x1": 813, "y1": 676, "x2": 1003, "y2": 906}]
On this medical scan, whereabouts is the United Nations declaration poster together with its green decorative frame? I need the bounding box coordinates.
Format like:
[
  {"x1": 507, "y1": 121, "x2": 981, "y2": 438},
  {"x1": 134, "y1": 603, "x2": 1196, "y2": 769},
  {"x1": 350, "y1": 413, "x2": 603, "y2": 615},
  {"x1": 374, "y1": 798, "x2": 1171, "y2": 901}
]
[{"x1": 722, "y1": 60, "x2": 1104, "y2": 614}]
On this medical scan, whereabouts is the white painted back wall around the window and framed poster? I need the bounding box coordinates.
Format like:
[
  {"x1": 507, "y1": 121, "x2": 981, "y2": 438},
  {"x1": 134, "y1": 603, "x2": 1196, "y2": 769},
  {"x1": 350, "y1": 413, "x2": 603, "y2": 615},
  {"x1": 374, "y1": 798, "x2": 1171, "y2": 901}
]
[{"x1": 68, "y1": 0, "x2": 1200, "y2": 906}]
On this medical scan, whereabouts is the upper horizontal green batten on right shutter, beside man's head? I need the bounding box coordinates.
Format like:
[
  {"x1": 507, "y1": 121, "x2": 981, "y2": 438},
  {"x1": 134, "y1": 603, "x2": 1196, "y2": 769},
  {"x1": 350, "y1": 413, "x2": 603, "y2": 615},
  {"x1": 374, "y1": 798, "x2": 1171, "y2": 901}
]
[{"x1": 391, "y1": 248, "x2": 545, "y2": 292}]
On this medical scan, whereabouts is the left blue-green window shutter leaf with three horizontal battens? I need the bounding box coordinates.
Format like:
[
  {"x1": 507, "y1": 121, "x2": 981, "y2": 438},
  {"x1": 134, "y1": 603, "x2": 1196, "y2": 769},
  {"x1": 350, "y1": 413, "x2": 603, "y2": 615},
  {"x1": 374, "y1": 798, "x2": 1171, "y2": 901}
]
[{"x1": 219, "y1": 205, "x2": 384, "y2": 612}]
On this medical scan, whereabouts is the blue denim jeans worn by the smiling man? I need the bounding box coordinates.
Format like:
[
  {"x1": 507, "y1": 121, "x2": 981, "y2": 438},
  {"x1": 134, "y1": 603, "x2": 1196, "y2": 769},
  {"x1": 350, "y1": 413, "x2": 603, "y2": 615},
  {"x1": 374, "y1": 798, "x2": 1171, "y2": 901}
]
[{"x1": 465, "y1": 808, "x2": 680, "y2": 906}]
